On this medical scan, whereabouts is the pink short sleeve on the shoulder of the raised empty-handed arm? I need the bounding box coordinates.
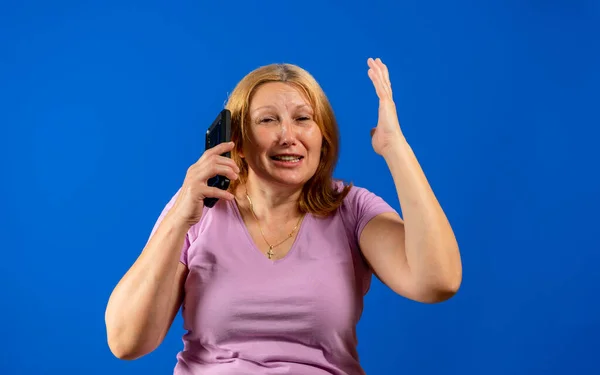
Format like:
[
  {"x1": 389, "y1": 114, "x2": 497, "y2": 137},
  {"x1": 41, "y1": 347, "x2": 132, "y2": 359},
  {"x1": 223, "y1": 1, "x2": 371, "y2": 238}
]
[{"x1": 346, "y1": 186, "x2": 397, "y2": 242}]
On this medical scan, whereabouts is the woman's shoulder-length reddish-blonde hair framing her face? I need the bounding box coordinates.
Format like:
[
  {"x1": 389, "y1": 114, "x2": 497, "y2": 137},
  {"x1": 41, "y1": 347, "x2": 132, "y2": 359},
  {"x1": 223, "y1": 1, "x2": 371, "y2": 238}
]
[{"x1": 225, "y1": 64, "x2": 352, "y2": 216}]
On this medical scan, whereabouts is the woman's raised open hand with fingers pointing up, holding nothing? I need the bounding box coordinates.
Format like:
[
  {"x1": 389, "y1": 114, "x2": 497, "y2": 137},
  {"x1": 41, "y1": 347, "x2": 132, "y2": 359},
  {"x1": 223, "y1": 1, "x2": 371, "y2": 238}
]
[{"x1": 367, "y1": 58, "x2": 403, "y2": 156}]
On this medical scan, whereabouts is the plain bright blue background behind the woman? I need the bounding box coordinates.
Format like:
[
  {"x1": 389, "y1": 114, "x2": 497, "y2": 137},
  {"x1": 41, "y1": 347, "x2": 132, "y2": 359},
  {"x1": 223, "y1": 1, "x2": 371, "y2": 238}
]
[{"x1": 0, "y1": 0, "x2": 600, "y2": 375}]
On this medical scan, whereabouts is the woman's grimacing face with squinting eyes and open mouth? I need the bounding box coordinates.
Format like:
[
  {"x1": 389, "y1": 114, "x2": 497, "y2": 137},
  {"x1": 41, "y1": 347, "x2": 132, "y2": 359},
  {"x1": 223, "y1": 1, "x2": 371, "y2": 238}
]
[{"x1": 241, "y1": 82, "x2": 323, "y2": 187}]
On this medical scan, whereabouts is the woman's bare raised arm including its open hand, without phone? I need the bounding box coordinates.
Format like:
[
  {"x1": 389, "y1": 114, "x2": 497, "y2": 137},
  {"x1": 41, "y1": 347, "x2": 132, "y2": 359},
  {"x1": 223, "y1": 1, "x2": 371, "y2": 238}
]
[{"x1": 359, "y1": 59, "x2": 462, "y2": 303}]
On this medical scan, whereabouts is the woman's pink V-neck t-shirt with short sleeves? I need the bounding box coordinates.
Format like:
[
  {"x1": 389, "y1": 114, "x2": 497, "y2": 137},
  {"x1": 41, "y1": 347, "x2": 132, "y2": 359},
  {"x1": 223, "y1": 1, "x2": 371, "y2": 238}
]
[{"x1": 150, "y1": 181, "x2": 395, "y2": 375}]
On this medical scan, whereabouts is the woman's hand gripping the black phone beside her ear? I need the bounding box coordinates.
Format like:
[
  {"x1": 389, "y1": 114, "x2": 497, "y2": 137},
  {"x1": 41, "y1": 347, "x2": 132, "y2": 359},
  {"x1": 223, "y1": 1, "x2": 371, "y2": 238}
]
[{"x1": 170, "y1": 142, "x2": 240, "y2": 227}]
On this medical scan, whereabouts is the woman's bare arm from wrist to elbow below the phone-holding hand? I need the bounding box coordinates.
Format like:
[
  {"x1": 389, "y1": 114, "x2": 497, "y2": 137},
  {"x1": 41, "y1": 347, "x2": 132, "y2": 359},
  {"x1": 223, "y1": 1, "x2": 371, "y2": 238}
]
[{"x1": 105, "y1": 214, "x2": 190, "y2": 359}]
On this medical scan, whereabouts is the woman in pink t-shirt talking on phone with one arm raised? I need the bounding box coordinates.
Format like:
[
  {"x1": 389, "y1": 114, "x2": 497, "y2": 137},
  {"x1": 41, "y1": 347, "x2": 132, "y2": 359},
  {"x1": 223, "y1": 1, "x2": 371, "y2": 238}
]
[{"x1": 106, "y1": 59, "x2": 462, "y2": 375}]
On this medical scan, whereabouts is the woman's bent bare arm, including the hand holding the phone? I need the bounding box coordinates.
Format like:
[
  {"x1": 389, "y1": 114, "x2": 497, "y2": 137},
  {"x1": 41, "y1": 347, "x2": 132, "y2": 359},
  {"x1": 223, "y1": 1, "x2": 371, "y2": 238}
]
[{"x1": 105, "y1": 142, "x2": 240, "y2": 359}]
